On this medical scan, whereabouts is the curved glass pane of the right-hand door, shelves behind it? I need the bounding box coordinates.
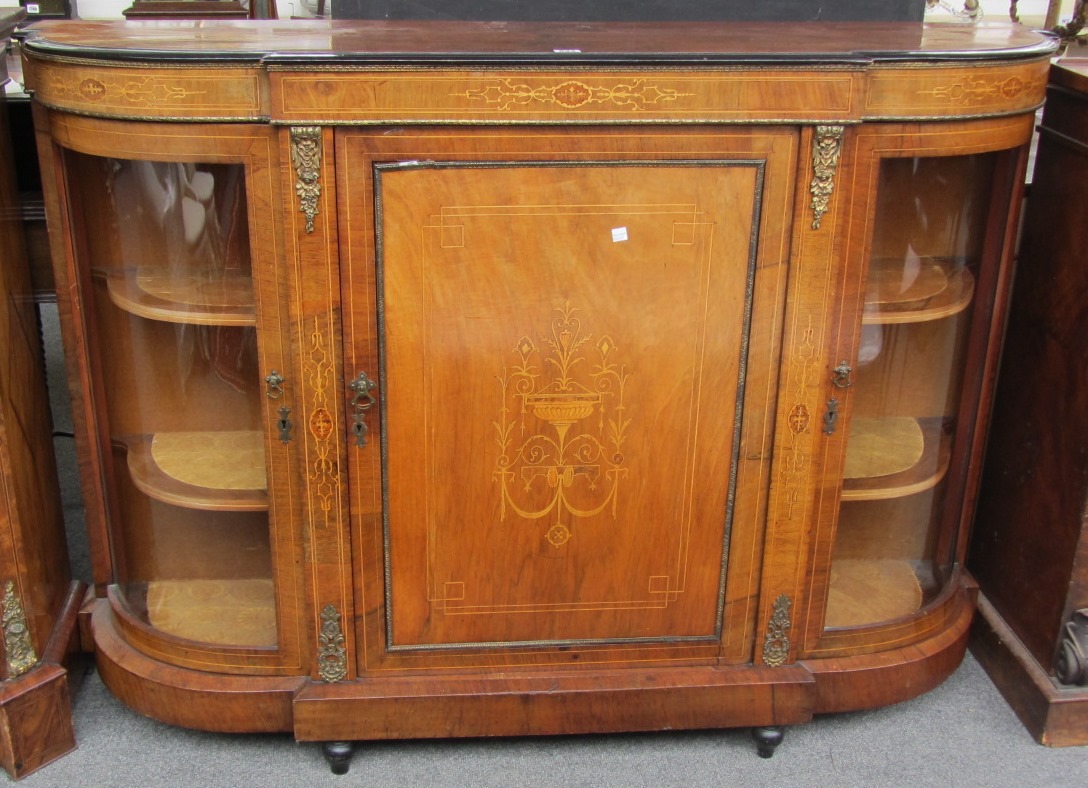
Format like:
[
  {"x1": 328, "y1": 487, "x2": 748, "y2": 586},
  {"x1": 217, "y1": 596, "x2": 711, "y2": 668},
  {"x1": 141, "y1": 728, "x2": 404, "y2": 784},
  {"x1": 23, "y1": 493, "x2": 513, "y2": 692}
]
[{"x1": 826, "y1": 155, "x2": 994, "y2": 627}]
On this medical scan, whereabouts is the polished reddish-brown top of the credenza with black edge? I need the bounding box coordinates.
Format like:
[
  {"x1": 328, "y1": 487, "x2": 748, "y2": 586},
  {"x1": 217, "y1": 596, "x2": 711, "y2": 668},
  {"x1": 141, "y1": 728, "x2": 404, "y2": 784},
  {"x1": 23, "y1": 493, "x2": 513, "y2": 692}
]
[{"x1": 14, "y1": 20, "x2": 1058, "y2": 67}]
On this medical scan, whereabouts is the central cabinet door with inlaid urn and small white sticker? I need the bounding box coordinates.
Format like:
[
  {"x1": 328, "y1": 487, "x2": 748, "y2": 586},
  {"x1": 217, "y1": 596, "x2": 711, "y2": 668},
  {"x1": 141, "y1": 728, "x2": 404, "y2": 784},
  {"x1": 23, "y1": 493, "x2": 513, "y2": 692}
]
[{"x1": 338, "y1": 130, "x2": 795, "y2": 658}]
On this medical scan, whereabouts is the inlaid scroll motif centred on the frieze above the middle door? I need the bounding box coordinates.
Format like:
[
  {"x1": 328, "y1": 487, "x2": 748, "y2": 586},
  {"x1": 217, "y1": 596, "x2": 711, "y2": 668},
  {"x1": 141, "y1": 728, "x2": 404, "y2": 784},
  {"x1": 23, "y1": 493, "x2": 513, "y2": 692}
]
[{"x1": 454, "y1": 79, "x2": 694, "y2": 110}]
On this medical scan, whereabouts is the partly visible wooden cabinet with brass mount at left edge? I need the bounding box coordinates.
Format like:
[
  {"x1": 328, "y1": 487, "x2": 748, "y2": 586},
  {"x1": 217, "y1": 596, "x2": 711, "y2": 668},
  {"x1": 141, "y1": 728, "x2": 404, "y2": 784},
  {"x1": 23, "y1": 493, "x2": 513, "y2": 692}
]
[{"x1": 0, "y1": 10, "x2": 86, "y2": 778}]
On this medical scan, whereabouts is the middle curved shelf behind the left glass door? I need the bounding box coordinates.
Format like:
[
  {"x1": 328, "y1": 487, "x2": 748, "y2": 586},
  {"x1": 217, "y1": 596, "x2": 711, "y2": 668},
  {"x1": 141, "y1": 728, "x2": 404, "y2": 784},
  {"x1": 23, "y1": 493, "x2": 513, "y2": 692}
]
[{"x1": 125, "y1": 430, "x2": 269, "y2": 512}]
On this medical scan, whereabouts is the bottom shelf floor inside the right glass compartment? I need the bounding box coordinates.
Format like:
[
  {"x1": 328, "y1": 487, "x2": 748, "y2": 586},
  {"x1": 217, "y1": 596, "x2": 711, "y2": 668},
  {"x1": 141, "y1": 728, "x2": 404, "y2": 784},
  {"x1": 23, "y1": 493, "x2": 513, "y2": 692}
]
[{"x1": 824, "y1": 558, "x2": 923, "y2": 628}]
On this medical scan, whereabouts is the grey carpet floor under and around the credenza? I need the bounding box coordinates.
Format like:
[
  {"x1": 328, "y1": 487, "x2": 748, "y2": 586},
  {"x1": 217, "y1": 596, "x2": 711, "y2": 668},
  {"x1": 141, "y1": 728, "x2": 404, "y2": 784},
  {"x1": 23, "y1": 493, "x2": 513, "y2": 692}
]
[{"x1": 29, "y1": 305, "x2": 1088, "y2": 788}]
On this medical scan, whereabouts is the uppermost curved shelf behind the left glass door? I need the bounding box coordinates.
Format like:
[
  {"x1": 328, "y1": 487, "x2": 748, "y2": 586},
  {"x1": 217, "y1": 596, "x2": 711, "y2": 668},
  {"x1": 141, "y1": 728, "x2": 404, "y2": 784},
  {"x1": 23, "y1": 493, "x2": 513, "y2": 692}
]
[{"x1": 104, "y1": 268, "x2": 257, "y2": 325}]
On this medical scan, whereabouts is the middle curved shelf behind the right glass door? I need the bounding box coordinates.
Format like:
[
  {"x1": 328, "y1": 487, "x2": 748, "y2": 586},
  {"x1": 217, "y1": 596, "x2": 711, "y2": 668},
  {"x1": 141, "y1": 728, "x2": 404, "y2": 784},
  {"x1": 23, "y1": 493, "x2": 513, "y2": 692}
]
[{"x1": 842, "y1": 417, "x2": 950, "y2": 501}]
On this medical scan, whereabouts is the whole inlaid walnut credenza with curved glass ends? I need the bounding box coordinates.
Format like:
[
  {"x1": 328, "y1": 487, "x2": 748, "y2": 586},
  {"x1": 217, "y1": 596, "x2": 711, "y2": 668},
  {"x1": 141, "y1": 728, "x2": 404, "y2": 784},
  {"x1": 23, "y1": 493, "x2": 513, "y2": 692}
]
[{"x1": 24, "y1": 16, "x2": 1052, "y2": 768}]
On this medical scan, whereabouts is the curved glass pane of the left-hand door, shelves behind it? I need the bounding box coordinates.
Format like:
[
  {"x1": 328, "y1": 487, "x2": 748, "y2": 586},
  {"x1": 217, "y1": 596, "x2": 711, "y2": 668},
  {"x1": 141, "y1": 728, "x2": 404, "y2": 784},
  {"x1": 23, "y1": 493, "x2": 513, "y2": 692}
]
[{"x1": 67, "y1": 152, "x2": 276, "y2": 647}]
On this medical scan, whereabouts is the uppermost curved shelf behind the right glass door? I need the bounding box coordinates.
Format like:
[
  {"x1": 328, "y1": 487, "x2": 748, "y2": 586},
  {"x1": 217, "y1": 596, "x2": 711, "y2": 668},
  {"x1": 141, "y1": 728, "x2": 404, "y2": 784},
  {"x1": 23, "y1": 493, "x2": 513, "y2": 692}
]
[{"x1": 862, "y1": 257, "x2": 975, "y2": 325}]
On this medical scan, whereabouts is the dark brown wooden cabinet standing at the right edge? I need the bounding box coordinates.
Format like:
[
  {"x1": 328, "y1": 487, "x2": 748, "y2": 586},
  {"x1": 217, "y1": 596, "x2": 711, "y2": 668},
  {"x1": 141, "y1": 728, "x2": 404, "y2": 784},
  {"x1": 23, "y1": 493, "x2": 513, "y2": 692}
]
[{"x1": 968, "y1": 58, "x2": 1088, "y2": 746}]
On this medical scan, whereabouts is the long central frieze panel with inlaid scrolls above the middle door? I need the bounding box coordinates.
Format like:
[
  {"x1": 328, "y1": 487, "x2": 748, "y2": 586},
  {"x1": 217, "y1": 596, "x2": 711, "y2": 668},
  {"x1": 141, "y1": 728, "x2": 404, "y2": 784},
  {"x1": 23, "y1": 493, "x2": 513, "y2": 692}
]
[{"x1": 269, "y1": 69, "x2": 861, "y2": 123}]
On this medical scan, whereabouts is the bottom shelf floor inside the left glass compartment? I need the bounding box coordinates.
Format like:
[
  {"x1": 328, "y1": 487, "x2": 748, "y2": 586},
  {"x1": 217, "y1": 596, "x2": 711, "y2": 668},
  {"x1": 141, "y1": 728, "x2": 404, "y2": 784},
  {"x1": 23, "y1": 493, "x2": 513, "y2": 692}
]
[{"x1": 147, "y1": 578, "x2": 276, "y2": 647}]
